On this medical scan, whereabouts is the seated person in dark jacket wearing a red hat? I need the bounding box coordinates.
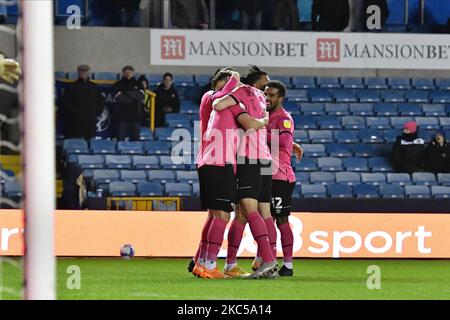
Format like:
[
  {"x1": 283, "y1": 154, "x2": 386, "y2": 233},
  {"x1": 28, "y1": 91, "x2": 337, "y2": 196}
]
[{"x1": 392, "y1": 121, "x2": 425, "y2": 173}]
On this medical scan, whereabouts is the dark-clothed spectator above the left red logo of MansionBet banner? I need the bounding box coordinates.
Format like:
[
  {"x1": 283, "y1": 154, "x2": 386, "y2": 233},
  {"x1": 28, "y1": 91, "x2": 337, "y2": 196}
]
[{"x1": 170, "y1": 0, "x2": 209, "y2": 29}]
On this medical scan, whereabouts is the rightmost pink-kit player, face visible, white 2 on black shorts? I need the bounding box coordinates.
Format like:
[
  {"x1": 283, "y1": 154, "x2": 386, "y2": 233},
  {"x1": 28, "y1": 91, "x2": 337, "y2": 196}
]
[{"x1": 264, "y1": 80, "x2": 295, "y2": 276}]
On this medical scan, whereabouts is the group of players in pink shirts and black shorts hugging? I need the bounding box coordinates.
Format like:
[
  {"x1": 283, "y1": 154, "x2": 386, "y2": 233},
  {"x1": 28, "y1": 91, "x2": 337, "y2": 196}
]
[{"x1": 188, "y1": 66, "x2": 303, "y2": 279}]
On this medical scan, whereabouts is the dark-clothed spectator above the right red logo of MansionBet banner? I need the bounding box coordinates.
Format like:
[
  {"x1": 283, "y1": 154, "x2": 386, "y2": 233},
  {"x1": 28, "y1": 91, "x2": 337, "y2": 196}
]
[{"x1": 311, "y1": 0, "x2": 350, "y2": 31}]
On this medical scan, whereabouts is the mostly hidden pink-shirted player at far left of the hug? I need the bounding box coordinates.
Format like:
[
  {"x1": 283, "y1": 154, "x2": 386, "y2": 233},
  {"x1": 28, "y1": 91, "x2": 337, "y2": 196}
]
[{"x1": 188, "y1": 68, "x2": 240, "y2": 272}]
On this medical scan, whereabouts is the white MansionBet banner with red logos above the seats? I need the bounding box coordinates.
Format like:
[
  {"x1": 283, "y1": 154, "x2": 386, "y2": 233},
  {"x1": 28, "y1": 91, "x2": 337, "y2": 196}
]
[{"x1": 150, "y1": 29, "x2": 450, "y2": 70}]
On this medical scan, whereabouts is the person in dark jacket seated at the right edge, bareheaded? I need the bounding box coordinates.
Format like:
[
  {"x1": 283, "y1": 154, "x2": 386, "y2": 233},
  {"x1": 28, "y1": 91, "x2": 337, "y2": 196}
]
[{"x1": 425, "y1": 130, "x2": 450, "y2": 173}]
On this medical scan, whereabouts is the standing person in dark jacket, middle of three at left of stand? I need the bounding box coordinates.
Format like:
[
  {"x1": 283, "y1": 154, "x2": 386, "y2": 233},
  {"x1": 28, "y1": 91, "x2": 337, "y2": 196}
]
[{"x1": 114, "y1": 66, "x2": 144, "y2": 141}]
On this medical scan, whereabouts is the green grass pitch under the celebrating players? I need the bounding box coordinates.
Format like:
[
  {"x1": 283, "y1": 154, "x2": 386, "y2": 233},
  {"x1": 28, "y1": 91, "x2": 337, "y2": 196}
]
[{"x1": 0, "y1": 258, "x2": 450, "y2": 300}]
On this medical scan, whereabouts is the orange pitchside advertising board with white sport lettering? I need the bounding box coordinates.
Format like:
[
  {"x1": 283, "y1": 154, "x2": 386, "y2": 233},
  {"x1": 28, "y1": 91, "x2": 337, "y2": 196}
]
[{"x1": 0, "y1": 210, "x2": 450, "y2": 258}]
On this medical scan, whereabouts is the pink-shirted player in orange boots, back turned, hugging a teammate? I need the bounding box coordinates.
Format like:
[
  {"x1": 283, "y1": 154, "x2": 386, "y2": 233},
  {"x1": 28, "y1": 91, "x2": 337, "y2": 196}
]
[{"x1": 193, "y1": 71, "x2": 268, "y2": 279}]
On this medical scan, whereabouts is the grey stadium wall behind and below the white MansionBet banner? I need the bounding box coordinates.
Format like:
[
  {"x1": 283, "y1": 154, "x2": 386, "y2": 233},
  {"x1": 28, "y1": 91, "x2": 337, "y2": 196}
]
[{"x1": 55, "y1": 26, "x2": 450, "y2": 78}]
